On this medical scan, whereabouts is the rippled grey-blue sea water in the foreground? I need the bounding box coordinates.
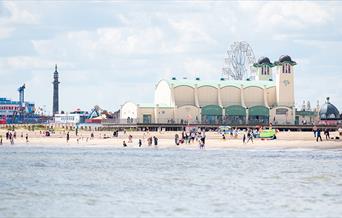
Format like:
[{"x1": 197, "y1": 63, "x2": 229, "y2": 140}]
[{"x1": 0, "y1": 147, "x2": 342, "y2": 217}]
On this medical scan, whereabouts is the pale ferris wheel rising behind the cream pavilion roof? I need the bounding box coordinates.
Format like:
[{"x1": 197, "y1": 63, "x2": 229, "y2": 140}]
[{"x1": 222, "y1": 42, "x2": 255, "y2": 80}]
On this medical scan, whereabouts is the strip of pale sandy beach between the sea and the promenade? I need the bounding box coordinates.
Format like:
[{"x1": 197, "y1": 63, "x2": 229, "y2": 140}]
[{"x1": 0, "y1": 129, "x2": 342, "y2": 149}]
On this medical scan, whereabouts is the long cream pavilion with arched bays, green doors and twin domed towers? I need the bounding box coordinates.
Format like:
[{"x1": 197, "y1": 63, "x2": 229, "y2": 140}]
[{"x1": 120, "y1": 56, "x2": 296, "y2": 125}]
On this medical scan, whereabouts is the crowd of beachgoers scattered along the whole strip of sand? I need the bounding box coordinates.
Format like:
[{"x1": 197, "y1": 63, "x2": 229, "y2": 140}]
[{"x1": 0, "y1": 126, "x2": 342, "y2": 146}]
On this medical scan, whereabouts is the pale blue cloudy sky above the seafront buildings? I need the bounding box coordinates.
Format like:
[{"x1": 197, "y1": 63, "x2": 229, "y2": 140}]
[{"x1": 0, "y1": 0, "x2": 342, "y2": 113}]
